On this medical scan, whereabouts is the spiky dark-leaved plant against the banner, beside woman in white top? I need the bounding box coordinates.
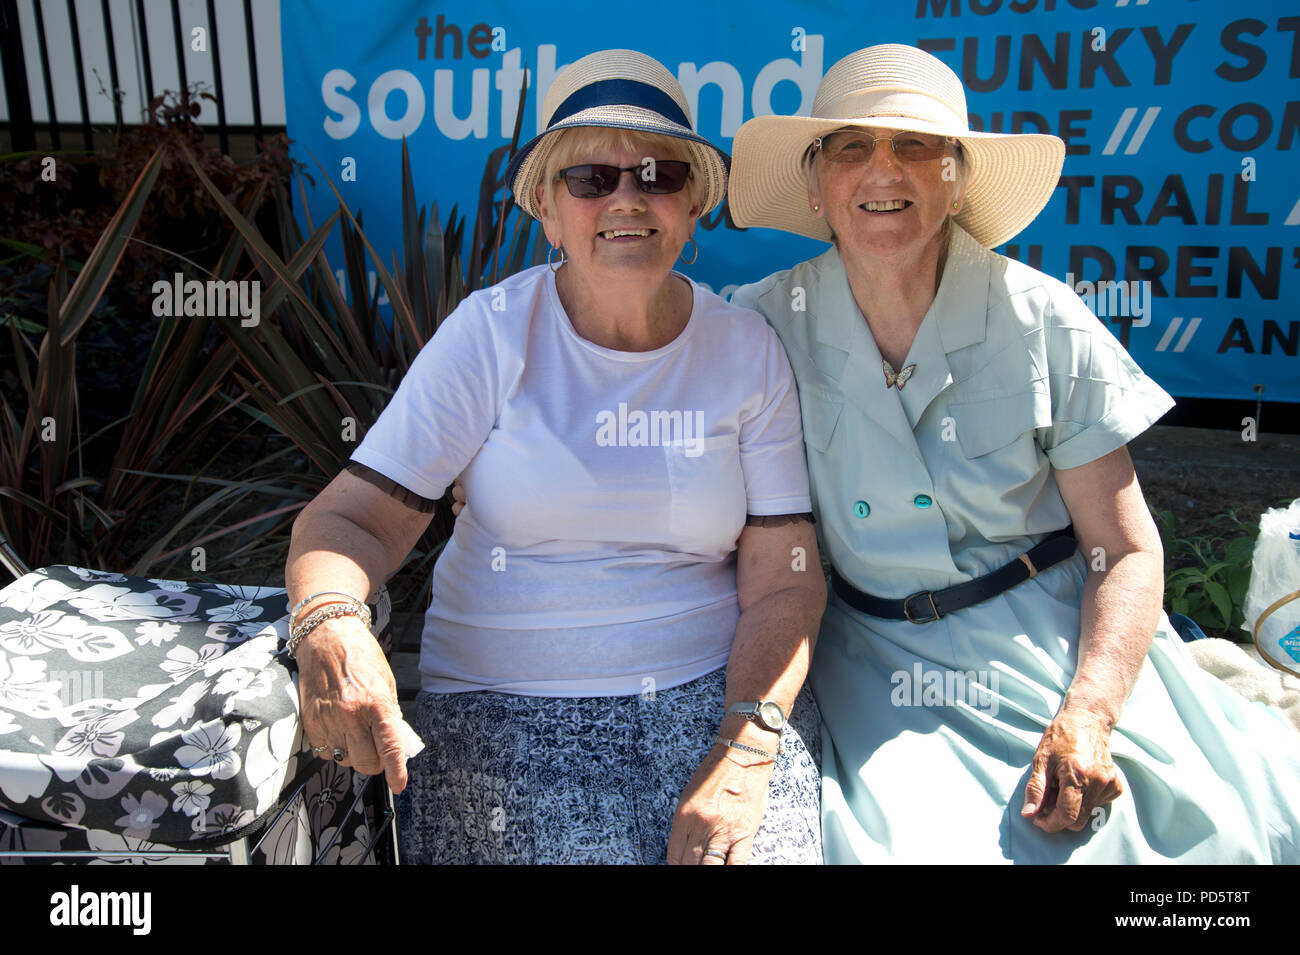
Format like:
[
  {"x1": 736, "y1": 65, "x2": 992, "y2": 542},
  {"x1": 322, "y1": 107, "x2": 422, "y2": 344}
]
[{"x1": 153, "y1": 74, "x2": 545, "y2": 600}]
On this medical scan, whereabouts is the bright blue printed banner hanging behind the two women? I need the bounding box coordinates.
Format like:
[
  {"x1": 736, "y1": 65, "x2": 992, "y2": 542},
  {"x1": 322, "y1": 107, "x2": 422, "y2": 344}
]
[{"x1": 281, "y1": 0, "x2": 1300, "y2": 401}]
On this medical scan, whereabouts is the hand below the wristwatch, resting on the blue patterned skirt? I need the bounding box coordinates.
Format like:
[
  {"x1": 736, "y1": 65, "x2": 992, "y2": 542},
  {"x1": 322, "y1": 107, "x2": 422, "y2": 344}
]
[{"x1": 668, "y1": 746, "x2": 775, "y2": 865}]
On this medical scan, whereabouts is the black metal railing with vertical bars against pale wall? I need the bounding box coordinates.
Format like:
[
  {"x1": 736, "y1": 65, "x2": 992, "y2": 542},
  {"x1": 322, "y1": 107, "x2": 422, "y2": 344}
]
[{"x1": 0, "y1": 0, "x2": 283, "y2": 153}]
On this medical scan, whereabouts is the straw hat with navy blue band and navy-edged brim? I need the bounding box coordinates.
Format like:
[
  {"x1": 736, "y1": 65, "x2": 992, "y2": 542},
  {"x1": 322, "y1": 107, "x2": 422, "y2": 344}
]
[{"x1": 506, "y1": 49, "x2": 731, "y2": 218}]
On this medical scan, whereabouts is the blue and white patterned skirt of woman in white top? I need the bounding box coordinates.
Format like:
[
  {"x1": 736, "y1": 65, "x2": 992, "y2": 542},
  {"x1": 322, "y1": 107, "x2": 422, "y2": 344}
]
[{"x1": 398, "y1": 669, "x2": 822, "y2": 864}]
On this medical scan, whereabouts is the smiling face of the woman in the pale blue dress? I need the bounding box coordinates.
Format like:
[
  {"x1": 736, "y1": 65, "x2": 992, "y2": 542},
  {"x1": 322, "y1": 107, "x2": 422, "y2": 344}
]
[{"x1": 809, "y1": 127, "x2": 962, "y2": 262}]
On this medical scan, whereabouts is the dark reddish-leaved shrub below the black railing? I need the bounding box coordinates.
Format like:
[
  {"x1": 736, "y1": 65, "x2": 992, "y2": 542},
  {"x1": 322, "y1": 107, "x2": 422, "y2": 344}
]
[{"x1": 0, "y1": 84, "x2": 294, "y2": 436}]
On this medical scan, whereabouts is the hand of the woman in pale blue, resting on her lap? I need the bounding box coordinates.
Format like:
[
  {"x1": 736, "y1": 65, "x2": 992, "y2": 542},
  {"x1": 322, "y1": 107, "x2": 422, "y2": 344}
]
[{"x1": 1021, "y1": 708, "x2": 1125, "y2": 833}]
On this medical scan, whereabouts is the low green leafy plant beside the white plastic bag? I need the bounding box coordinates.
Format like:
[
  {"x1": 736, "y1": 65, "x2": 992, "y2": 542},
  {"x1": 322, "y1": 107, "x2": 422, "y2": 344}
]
[{"x1": 1156, "y1": 511, "x2": 1258, "y2": 641}]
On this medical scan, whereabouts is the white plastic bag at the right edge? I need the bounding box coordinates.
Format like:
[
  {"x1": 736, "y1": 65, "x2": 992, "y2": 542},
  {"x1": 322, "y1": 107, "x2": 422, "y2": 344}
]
[{"x1": 1242, "y1": 500, "x2": 1300, "y2": 676}]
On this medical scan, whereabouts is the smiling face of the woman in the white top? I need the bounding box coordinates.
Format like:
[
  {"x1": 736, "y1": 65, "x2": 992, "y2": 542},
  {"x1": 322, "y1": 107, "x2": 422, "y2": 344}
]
[{"x1": 537, "y1": 129, "x2": 701, "y2": 289}]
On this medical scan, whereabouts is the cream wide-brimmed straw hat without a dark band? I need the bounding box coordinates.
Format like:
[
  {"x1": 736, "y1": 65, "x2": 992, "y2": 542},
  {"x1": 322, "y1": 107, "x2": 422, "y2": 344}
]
[{"x1": 731, "y1": 43, "x2": 1065, "y2": 248}]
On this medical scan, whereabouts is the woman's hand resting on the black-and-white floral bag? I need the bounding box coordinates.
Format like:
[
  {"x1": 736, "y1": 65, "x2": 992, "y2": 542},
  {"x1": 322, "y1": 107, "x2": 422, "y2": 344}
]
[{"x1": 296, "y1": 617, "x2": 407, "y2": 793}]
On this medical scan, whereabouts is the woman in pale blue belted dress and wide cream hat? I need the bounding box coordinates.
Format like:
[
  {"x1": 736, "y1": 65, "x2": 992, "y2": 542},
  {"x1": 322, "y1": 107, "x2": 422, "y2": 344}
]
[{"x1": 731, "y1": 44, "x2": 1300, "y2": 863}]
